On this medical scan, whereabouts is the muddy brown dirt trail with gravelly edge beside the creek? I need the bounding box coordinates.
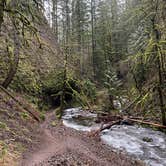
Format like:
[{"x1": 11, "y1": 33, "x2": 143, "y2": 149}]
[{"x1": 20, "y1": 112, "x2": 143, "y2": 166}]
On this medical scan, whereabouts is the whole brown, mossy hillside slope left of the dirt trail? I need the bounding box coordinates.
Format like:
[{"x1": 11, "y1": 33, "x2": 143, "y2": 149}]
[{"x1": 0, "y1": 12, "x2": 63, "y2": 166}]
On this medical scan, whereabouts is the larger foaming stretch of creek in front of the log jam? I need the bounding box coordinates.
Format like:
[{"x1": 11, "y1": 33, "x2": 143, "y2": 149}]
[{"x1": 101, "y1": 125, "x2": 166, "y2": 166}]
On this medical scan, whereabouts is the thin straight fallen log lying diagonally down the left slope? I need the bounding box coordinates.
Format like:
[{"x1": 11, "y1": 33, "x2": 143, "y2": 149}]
[{"x1": 0, "y1": 85, "x2": 40, "y2": 122}]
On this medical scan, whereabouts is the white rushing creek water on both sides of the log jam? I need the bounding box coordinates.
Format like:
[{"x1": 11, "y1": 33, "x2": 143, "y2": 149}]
[{"x1": 63, "y1": 108, "x2": 166, "y2": 166}]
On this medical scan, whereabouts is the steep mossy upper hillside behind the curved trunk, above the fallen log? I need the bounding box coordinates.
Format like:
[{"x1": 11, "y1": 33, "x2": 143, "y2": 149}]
[{"x1": 0, "y1": 15, "x2": 63, "y2": 93}]
